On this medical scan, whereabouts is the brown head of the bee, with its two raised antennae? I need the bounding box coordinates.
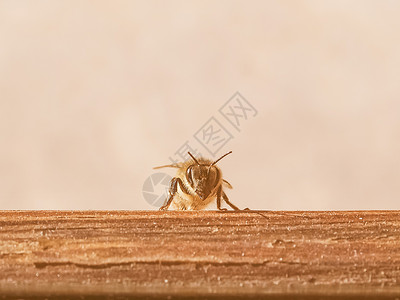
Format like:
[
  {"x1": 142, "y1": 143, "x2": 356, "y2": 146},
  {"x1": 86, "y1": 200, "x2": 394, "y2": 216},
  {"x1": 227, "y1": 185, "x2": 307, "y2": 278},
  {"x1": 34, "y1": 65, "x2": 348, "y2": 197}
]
[{"x1": 186, "y1": 151, "x2": 232, "y2": 200}]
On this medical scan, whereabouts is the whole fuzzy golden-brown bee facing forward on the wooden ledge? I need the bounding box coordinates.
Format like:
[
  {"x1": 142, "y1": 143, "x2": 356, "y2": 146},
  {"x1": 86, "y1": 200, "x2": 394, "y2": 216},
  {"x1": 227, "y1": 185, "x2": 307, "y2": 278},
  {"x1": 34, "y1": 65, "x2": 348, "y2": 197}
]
[{"x1": 154, "y1": 151, "x2": 240, "y2": 210}]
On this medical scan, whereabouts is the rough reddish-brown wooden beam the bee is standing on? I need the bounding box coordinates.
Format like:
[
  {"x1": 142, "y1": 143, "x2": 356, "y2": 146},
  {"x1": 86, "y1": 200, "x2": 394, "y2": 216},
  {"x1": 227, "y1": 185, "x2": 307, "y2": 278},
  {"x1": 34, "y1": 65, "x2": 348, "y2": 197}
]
[{"x1": 0, "y1": 211, "x2": 400, "y2": 299}]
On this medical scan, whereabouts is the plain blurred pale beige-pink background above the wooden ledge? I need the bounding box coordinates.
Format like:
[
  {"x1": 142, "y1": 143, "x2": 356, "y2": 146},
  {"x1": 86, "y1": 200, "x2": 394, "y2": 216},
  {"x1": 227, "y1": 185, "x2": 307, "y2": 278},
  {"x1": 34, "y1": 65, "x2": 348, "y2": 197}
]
[{"x1": 0, "y1": 0, "x2": 400, "y2": 210}]
